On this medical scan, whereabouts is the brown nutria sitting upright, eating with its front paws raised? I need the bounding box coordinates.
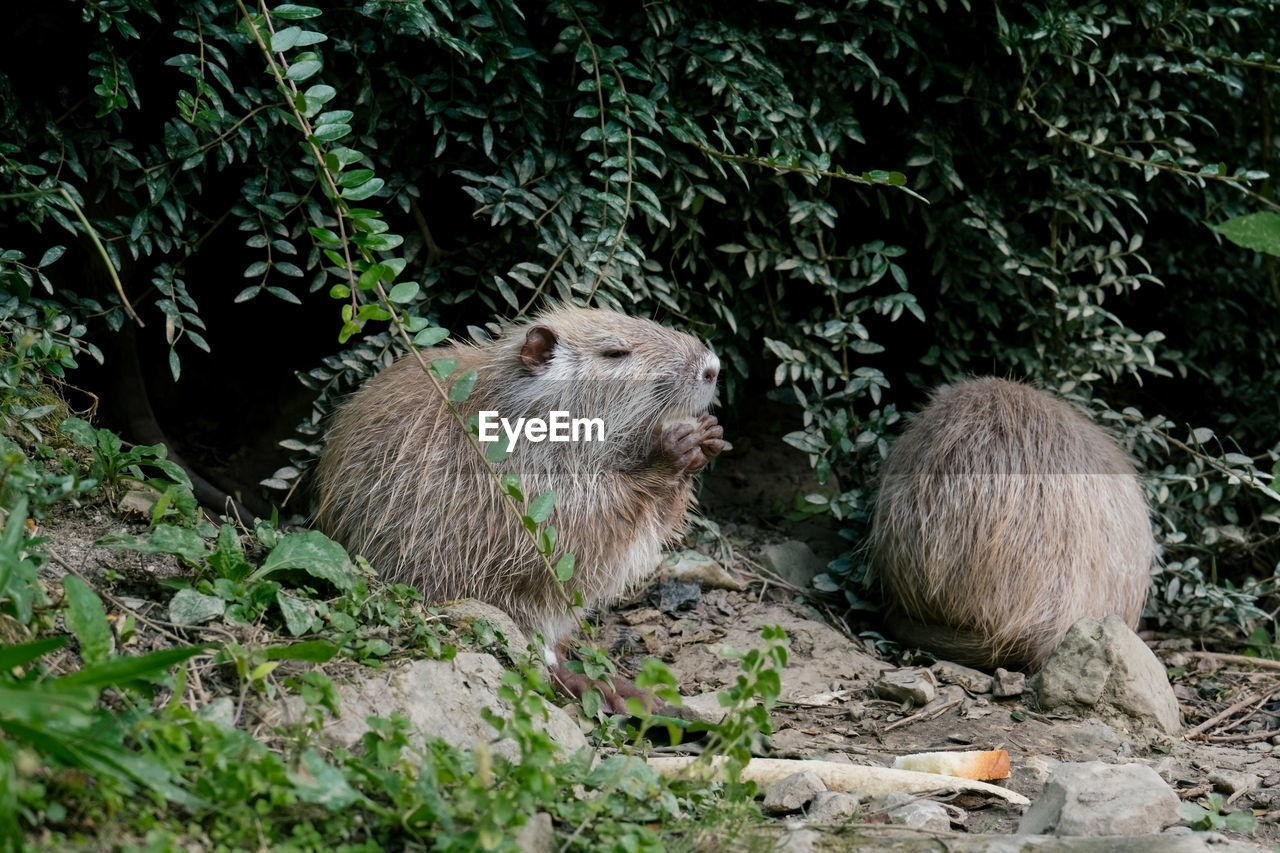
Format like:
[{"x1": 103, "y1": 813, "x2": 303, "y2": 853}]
[{"x1": 315, "y1": 306, "x2": 724, "y2": 711}]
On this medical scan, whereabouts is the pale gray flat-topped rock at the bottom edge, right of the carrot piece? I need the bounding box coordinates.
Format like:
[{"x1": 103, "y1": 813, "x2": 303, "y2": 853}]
[{"x1": 1018, "y1": 761, "x2": 1179, "y2": 836}]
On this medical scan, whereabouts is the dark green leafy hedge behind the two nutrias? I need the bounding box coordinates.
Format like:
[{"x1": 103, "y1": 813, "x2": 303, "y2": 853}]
[{"x1": 0, "y1": 0, "x2": 1280, "y2": 630}]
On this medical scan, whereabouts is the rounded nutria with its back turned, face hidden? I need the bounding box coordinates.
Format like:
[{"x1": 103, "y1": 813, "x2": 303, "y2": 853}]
[{"x1": 870, "y1": 378, "x2": 1157, "y2": 669}]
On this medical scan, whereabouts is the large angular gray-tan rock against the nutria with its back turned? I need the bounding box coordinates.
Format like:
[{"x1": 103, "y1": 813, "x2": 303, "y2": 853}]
[{"x1": 1030, "y1": 616, "x2": 1181, "y2": 734}]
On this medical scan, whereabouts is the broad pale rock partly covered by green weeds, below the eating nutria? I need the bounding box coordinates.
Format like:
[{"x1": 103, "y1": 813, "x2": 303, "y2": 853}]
[{"x1": 262, "y1": 652, "x2": 588, "y2": 761}]
